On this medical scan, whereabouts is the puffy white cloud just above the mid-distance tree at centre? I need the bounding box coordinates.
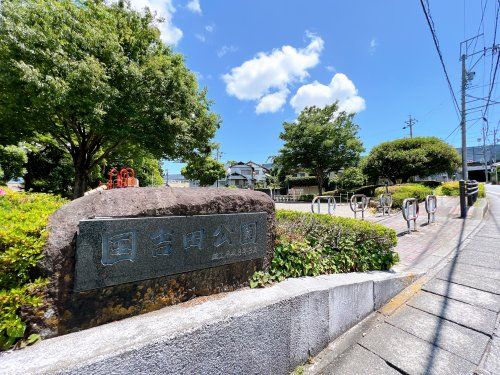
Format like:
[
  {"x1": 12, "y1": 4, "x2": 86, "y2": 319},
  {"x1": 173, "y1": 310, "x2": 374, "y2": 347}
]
[{"x1": 290, "y1": 73, "x2": 366, "y2": 113}]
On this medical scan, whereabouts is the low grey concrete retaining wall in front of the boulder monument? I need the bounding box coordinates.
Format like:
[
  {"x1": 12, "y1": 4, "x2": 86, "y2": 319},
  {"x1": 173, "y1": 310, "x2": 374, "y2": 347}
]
[{"x1": 0, "y1": 272, "x2": 421, "y2": 374}]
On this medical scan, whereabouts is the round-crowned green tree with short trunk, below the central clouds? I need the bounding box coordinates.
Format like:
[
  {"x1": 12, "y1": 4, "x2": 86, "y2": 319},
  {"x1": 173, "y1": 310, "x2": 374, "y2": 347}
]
[{"x1": 278, "y1": 103, "x2": 363, "y2": 194}]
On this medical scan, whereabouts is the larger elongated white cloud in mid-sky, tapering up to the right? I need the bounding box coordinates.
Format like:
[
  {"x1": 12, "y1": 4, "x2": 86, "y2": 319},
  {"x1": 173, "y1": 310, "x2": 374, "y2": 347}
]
[{"x1": 222, "y1": 33, "x2": 324, "y2": 113}]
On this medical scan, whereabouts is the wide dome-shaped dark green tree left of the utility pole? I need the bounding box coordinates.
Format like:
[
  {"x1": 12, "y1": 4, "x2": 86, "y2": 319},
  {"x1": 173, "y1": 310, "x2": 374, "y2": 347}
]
[{"x1": 363, "y1": 137, "x2": 460, "y2": 183}]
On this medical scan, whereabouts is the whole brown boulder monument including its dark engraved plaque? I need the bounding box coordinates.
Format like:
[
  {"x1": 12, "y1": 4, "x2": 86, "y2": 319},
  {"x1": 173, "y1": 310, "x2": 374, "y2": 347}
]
[{"x1": 38, "y1": 187, "x2": 275, "y2": 337}]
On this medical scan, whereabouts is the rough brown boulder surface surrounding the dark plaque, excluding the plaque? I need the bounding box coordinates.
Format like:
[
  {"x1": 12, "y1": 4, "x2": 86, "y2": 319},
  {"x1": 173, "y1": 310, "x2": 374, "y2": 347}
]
[{"x1": 37, "y1": 187, "x2": 275, "y2": 336}]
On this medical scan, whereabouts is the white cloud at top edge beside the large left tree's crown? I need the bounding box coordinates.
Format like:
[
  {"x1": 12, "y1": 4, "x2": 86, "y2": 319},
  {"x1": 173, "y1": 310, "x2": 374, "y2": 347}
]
[{"x1": 130, "y1": 0, "x2": 182, "y2": 45}]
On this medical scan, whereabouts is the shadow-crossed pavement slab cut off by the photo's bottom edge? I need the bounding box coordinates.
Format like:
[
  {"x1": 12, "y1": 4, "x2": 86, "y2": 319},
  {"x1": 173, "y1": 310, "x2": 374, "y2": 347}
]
[{"x1": 360, "y1": 323, "x2": 475, "y2": 375}]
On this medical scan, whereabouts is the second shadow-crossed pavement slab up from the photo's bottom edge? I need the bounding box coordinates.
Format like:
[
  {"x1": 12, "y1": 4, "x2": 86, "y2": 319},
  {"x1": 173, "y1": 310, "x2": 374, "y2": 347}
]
[{"x1": 386, "y1": 306, "x2": 489, "y2": 364}]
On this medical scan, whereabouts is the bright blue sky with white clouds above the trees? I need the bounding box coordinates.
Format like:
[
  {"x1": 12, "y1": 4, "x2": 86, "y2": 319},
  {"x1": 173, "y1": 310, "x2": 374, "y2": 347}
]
[{"x1": 132, "y1": 0, "x2": 498, "y2": 173}]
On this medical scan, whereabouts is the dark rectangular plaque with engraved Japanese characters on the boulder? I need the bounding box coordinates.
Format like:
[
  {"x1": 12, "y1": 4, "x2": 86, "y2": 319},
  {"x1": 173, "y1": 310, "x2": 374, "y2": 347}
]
[{"x1": 74, "y1": 212, "x2": 267, "y2": 292}]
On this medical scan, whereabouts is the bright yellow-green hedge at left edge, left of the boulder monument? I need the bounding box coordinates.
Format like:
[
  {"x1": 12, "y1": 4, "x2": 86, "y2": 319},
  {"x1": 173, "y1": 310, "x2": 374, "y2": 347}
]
[{"x1": 0, "y1": 187, "x2": 65, "y2": 349}]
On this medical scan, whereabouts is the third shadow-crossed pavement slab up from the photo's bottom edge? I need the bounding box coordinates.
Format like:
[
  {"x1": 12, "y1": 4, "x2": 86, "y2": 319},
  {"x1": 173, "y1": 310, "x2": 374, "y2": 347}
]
[{"x1": 408, "y1": 292, "x2": 497, "y2": 335}]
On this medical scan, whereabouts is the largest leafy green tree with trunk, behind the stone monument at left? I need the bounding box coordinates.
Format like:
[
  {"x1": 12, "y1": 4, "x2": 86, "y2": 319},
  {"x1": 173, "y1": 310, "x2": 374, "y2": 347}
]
[{"x1": 0, "y1": 0, "x2": 219, "y2": 197}]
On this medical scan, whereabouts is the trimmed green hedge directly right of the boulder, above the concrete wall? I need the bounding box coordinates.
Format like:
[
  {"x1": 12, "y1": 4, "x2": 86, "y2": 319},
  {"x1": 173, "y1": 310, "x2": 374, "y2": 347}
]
[{"x1": 250, "y1": 210, "x2": 399, "y2": 287}]
